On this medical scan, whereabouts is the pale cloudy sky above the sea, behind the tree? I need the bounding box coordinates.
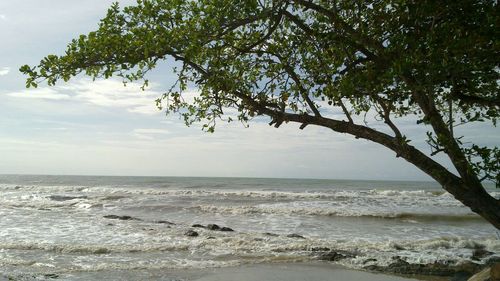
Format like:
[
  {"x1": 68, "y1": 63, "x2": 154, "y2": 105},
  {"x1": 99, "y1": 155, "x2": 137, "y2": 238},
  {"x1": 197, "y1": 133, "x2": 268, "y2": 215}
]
[{"x1": 0, "y1": 0, "x2": 500, "y2": 180}]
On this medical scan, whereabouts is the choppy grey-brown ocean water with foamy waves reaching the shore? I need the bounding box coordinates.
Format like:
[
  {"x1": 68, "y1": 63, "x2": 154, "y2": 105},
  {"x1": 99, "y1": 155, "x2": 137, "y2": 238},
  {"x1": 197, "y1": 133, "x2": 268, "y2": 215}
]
[{"x1": 0, "y1": 175, "x2": 500, "y2": 280}]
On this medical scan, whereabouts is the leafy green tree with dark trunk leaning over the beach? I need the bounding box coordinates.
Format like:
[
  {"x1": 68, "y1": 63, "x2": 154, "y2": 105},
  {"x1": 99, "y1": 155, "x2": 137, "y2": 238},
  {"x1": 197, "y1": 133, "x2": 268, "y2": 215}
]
[{"x1": 20, "y1": 0, "x2": 500, "y2": 226}]
